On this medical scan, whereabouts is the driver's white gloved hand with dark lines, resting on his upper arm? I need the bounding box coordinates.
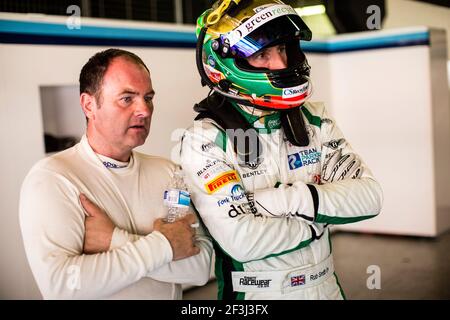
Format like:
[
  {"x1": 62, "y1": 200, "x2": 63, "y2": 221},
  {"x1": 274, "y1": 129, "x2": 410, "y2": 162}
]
[{"x1": 322, "y1": 149, "x2": 362, "y2": 182}]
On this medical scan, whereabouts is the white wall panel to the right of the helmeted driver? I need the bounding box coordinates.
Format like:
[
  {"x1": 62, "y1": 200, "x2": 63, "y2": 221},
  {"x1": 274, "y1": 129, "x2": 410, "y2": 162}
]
[{"x1": 308, "y1": 27, "x2": 450, "y2": 237}]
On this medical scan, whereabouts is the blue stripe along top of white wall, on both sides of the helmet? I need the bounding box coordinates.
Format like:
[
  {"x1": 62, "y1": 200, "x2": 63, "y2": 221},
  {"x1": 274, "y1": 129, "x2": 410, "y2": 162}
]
[{"x1": 0, "y1": 20, "x2": 430, "y2": 53}]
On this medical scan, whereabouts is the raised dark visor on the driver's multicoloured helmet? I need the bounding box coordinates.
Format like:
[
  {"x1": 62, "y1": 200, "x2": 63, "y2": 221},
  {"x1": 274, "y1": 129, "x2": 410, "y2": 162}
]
[{"x1": 225, "y1": 15, "x2": 311, "y2": 58}]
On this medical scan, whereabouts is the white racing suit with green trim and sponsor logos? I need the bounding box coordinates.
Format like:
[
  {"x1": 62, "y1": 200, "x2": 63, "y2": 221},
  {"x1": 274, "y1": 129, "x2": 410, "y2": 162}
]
[{"x1": 181, "y1": 102, "x2": 382, "y2": 299}]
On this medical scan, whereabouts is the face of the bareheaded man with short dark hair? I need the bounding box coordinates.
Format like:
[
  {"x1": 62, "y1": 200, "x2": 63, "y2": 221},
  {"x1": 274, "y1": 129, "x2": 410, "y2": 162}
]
[{"x1": 89, "y1": 57, "x2": 155, "y2": 152}]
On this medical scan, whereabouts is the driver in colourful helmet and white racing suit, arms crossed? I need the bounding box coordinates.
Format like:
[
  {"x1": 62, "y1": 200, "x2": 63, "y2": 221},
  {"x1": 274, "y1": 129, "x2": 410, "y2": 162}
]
[{"x1": 181, "y1": 0, "x2": 382, "y2": 299}]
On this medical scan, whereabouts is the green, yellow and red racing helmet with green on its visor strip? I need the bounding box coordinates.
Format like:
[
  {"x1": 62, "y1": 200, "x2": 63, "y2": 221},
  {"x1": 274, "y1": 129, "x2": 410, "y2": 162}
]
[{"x1": 196, "y1": 0, "x2": 312, "y2": 110}]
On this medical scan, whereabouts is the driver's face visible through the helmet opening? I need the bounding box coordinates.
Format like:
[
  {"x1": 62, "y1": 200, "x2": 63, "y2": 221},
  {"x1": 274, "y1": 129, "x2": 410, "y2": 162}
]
[{"x1": 247, "y1": 44, "x2": 287, "y2": 70}]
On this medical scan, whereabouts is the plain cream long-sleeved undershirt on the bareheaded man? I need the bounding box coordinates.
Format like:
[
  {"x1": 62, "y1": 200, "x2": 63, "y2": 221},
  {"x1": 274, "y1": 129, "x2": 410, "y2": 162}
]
[{"x1": 20, "y1": 136, "x2": 212, "y2": 299}]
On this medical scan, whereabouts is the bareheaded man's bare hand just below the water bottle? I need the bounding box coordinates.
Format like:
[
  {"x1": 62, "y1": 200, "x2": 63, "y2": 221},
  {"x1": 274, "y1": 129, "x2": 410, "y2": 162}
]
[{"x1": 153, "y1": 213, "x2": 200, "y2": 261}]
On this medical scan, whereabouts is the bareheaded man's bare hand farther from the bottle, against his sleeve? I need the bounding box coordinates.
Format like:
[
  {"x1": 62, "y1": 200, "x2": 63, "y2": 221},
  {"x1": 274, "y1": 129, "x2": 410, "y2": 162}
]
[{"x1": 80, "y1": 194, "x2": 115, "y2": 254}]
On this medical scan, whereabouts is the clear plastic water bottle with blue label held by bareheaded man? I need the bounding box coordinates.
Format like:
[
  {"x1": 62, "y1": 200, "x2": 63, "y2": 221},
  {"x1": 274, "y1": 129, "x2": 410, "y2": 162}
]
[{"x1": 164, "y1": 167, "x2": 191, "y2": 223}]
